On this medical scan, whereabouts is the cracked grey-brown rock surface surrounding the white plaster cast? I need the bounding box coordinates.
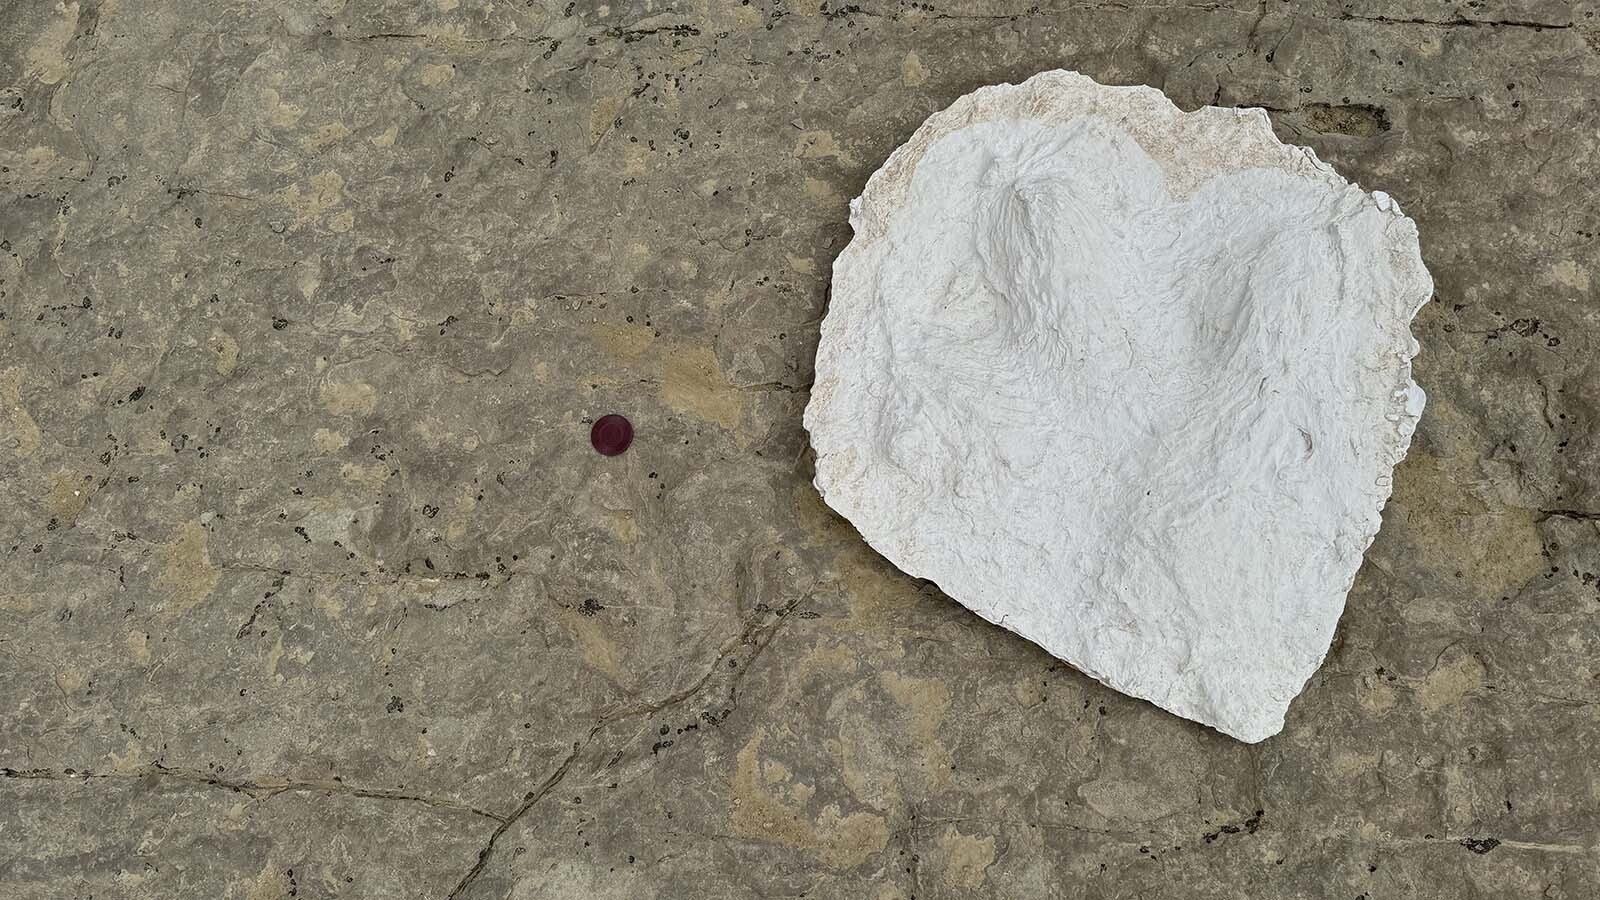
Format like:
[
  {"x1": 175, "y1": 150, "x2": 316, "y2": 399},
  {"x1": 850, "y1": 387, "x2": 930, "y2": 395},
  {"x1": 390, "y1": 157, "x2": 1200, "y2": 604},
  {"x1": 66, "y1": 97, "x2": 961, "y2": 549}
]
[{"x1": 0, "y1": 0, "x2": 1600, "y2": 900}]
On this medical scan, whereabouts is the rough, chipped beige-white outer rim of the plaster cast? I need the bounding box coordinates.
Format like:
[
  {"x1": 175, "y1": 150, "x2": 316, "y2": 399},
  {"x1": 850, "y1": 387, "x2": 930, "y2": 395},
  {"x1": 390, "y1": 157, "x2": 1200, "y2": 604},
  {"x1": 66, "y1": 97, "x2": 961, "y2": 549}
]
[{"x1": 805, "y1": 69, "x2": 1434, "y2": 743}]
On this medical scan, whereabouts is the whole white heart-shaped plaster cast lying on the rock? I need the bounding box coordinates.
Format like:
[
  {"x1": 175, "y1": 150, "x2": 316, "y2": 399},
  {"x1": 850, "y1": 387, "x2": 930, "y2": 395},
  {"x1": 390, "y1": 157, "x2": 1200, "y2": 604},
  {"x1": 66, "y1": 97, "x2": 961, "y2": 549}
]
[{"x1": 805, "y1": 70, "x2": 1434, "y2": 741}]
